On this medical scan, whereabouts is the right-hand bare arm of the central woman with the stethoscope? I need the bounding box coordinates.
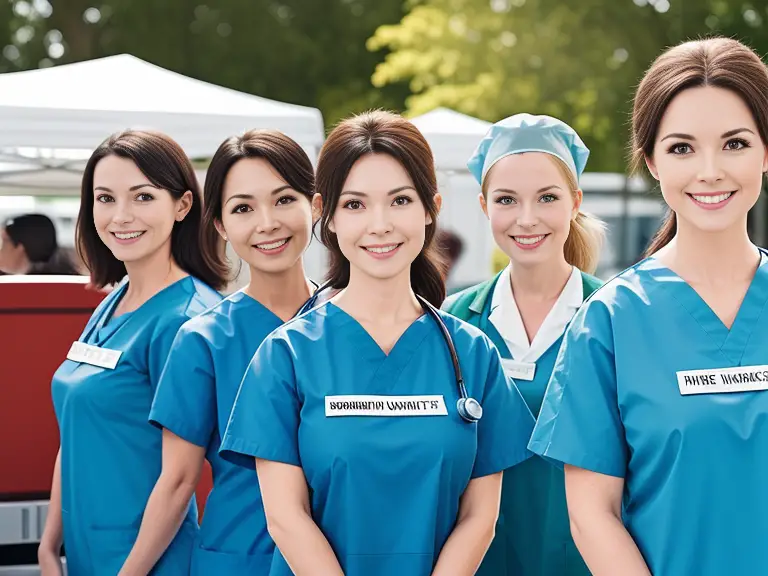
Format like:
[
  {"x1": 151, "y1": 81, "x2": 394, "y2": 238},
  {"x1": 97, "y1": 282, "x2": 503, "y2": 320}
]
[{"x1": 432, "y1": 472, "x2": 503, "y2": 576}]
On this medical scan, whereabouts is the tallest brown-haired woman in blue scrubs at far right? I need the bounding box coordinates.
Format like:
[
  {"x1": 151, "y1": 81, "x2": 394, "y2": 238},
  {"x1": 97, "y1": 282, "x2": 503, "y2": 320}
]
[{"x1": 530, "y1": 38, "x2": 768, "y2": 576}]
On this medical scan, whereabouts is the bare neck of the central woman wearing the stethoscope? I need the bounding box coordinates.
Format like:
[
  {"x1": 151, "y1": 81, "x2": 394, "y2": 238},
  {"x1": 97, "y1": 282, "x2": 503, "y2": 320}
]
[{"x1": 333, "y1": 267, "x2": 423, "y2": 324}]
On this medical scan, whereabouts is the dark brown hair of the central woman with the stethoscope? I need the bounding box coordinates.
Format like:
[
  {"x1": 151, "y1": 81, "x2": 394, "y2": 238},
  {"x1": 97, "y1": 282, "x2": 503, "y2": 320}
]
[{"x1": 315, "y1": 110, "x2": 445, "y2": 308}]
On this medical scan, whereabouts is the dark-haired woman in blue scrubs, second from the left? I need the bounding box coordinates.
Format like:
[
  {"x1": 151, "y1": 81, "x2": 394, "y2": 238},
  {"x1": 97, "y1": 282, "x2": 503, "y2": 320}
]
[{"x1": 126, "y1": 130, "x2": 314, "y2": 576}]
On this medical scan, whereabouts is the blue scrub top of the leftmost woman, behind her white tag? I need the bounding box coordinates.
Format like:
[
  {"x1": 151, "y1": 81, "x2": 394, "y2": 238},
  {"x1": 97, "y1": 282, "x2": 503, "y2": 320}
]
[{"x1": 51, "y1": 276, "x2": 221, "y2": 576}]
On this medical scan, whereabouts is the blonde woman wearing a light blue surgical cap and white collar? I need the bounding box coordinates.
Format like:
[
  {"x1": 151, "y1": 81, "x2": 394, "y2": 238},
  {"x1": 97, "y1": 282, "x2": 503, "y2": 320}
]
[{"x1": 443, "y1": 114, "x2": 603, "y2": 576}]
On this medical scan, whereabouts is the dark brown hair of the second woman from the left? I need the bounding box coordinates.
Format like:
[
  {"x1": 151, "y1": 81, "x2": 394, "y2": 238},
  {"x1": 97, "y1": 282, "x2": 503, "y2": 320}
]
[{"x1": 200, "y1": 130, "x2": 315, "y2": 284}]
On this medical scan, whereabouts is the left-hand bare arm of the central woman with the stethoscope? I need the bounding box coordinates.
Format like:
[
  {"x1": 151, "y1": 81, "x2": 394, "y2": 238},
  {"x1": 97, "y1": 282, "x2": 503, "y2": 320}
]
[{"x1": 256, "y1": 458, "x2": 344, "y2": 576}]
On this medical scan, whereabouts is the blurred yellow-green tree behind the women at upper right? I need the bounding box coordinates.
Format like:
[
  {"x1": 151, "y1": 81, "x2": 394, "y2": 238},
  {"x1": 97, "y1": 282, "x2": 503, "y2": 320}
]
[{"x1": 368, "y1": 0, "x2": 768, "y2": 171}]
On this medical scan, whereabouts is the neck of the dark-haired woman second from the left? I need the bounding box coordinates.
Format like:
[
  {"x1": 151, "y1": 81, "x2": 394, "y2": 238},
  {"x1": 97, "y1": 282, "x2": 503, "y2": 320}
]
[{"x1": 245, "y1": 260, "x2": 314, "y2": 321}]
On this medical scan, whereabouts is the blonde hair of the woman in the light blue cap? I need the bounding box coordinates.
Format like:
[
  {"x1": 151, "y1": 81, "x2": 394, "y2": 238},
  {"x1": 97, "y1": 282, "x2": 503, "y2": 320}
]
[{"x1": 481, "y1": 152, "x2": 605, "y2": 274}]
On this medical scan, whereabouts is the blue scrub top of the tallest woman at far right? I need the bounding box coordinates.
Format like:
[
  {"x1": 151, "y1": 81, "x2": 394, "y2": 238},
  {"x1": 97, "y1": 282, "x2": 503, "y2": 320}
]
[{"x1": 530, "y1": 254, "x2": 768, "y2": 576}]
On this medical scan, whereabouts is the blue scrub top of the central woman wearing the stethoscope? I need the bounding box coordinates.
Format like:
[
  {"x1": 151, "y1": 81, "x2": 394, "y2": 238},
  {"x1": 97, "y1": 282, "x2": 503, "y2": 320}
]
[{"x1": 222, "y1": 302, "x2": 533, "y2": 576}]
